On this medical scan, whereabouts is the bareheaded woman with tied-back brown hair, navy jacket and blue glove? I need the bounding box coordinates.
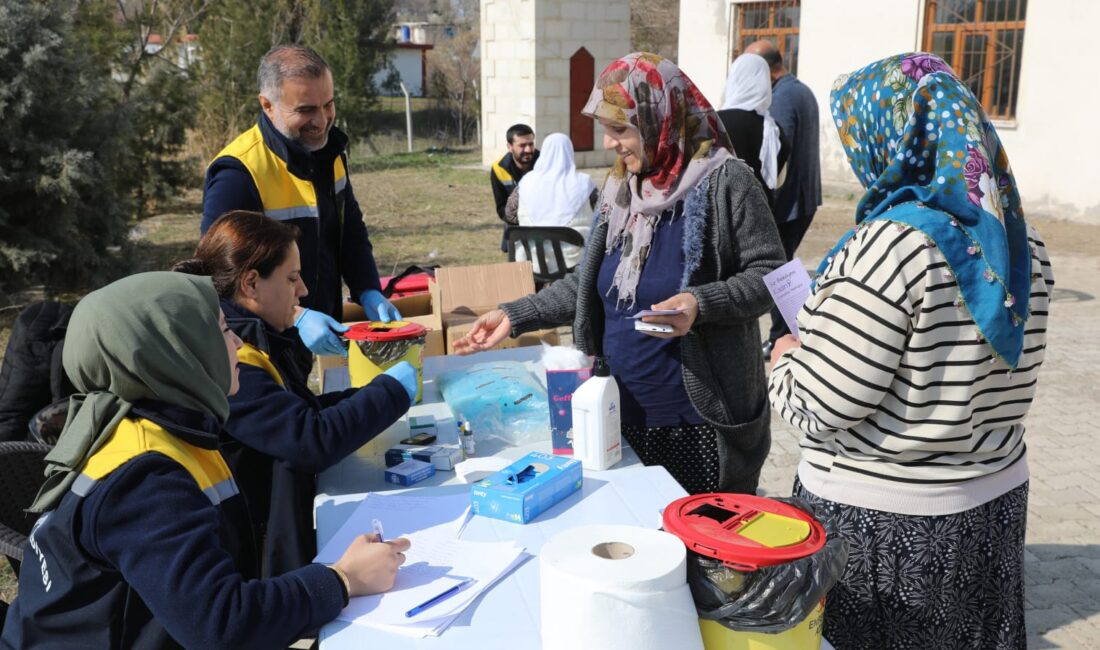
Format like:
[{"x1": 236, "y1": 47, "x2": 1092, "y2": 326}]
[{"x1": 175, "y1": 211, "x2": 417, "y2": 576}]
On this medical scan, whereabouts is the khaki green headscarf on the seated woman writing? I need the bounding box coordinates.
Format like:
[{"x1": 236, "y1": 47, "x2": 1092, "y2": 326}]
[{"x1": 30, "y1": 272, "x2": 231, "y2": 513}]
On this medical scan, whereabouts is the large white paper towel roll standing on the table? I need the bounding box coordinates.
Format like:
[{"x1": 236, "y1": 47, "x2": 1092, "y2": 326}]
[{"x1": 539, "y1": 526, "x2": 703, "y2": 650}]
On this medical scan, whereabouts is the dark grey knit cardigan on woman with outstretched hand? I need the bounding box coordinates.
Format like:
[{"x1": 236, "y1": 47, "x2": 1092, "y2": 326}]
[{"x1": 501, "y1": 159, "x2": 787, "y2": 493}]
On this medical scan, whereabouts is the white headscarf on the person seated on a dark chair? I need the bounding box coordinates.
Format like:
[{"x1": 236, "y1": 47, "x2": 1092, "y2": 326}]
[{"x1": 518, "y1": 133, "x2": 596, "y2": 225}]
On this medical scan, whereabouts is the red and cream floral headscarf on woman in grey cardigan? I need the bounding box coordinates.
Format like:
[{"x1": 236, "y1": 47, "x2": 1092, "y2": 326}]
[{"x1": 581, "y1": 52, "x2": 734, "y2": 305}]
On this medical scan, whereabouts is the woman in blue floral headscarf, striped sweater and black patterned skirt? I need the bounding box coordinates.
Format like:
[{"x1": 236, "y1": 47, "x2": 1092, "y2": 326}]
[{"x1": 770, "y1": 54, "x2": 1054, "y2": 650}]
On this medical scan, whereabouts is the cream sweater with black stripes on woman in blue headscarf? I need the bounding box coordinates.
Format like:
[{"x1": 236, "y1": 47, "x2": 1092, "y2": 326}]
[{"x1": 769, "y1": 221, "x2": 1054, "y2": 515}]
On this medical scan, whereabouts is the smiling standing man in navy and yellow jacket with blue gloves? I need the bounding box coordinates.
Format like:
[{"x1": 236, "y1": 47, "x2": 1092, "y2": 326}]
[{"x1": 200, "y1": 45, "x2": 400, "y2": 373}]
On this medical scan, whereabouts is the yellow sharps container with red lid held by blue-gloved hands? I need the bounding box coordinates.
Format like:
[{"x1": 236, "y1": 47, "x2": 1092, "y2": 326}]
[{"x1": 343, "y1": 320, "x2": 428, "y2": 401}]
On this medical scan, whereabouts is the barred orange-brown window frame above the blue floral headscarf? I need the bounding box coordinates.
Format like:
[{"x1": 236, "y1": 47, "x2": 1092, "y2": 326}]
[{"x1": 921, "y1": 0, "x2": 1027, "y2": 119}]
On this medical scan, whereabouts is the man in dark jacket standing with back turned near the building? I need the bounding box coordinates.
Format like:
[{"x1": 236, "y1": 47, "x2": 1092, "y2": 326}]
[{"x1": 745, "y1": 41, "x2": 822, "y2": 356}]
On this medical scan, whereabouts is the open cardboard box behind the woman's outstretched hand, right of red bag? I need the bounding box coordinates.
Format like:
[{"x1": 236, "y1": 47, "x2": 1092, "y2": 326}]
[{"x1": 436, "y1": 262, "x2": 559, "y2": 354}]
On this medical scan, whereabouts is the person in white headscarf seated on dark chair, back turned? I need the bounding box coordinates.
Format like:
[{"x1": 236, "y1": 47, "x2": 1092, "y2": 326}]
[{"x1": 504, "y1": 133, "x2": 600, "y2": 272}]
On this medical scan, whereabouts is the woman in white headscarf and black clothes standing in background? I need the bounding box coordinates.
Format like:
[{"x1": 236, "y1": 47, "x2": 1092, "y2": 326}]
[{"x1": 718, "y1": 54, "x2": 790, "y2": 203}]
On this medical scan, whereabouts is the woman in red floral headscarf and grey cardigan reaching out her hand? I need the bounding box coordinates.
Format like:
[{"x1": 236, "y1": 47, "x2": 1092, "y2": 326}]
[{"x1": 458, "y1": 53, "x2": 784, "y2": 493}]
